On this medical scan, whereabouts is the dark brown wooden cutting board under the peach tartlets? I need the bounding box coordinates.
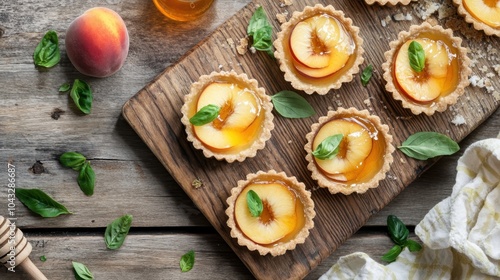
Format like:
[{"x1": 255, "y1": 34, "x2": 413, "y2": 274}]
[{"x1": 123, "y1": 0, "x2": 500, "y2": 279}]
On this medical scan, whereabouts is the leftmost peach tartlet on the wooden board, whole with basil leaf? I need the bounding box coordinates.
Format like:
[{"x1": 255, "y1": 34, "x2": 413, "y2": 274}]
[{"x1": 181, "y1": 71, "x2": 274, "y2": 162}]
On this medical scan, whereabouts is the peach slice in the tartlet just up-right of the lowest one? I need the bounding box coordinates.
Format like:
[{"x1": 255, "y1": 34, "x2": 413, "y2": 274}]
[{"x1": 312, "y1": 119, "x2": 372, "y2": 176}]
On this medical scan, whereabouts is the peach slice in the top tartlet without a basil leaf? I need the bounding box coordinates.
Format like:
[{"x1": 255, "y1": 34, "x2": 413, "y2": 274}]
[{"x1": 290, "y1": 15, "x2": 340, "y2": 68}]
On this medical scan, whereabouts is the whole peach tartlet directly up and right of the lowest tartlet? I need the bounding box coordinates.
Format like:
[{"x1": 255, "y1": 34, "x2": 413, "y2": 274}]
[{"x1": 304, "y1": 108, "x2": 394, "y2": 195}]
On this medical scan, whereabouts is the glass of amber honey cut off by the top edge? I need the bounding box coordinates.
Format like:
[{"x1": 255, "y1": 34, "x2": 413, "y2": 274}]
[{"x1": 153, "y1": 0, "x2": 214, "y2": 21}]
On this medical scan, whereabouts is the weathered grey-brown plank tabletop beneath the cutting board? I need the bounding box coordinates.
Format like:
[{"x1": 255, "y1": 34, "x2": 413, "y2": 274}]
[{"x1": 0, "y1": 0, "x2": 500, "y2": 279}]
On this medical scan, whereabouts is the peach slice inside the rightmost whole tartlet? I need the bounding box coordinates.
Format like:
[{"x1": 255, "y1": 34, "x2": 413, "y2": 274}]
[{"x1": 394, "y1": 38, "x2": 450, "y2": 102}]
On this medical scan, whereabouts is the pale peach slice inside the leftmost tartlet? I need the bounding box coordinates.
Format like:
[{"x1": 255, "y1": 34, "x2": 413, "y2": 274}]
[{"x1": 193, "y1": 83, "x2": 261, "y2": 149}]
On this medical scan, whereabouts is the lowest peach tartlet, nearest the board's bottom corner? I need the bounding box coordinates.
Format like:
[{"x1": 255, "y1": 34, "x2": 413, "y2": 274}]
[{"x1": 226, "y1": 170, "x2": 316, "y2": 256}]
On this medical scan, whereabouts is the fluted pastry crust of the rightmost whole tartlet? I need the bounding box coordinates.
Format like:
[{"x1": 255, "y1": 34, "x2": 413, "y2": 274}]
[{"x1": 382, "y1": 22, "x2": 472, "y2": 116}]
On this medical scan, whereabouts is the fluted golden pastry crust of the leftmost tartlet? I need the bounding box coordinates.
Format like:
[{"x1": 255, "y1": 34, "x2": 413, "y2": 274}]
[{"x1": 181, "y1": 70, "x2": 274, "y2": 163}]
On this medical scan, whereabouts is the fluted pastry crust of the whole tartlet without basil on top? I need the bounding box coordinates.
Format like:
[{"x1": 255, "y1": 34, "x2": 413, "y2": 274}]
[{"x1": 274, "y1": 4, "x2": 364, "y2": 95}]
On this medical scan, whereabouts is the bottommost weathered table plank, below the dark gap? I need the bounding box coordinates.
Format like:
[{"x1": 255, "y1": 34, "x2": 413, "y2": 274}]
[{"x1": 0, "y1": 230, "x2": 398, "y2": 280}]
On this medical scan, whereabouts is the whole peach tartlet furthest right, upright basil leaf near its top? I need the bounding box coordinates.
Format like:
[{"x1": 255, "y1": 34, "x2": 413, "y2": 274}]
[{"x1": 382, "y1": 22, "x2": 471, "y2": 116}]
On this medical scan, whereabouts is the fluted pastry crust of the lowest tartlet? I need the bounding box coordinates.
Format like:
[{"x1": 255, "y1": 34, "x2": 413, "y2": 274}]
[{"x1": 226, "y1": 170, "x2": 316, "y2": 256}]
